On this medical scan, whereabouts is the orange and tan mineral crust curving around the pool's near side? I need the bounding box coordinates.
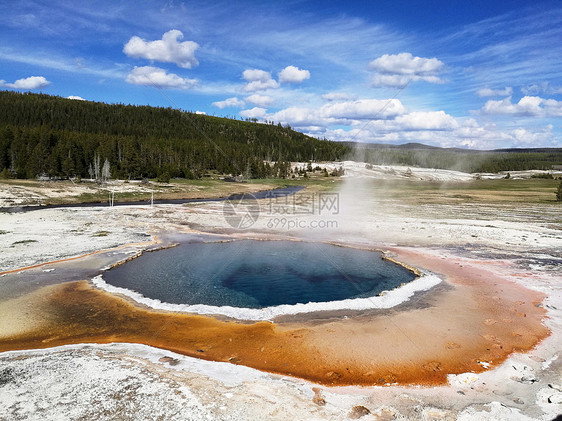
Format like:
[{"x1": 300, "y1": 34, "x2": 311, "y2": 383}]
[{"x1": 0, "y1": 249, "x2": 548, "y2": 385}]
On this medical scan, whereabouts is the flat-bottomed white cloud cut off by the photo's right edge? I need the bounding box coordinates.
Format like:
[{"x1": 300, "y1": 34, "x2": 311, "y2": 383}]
[{"x1": 481, "y1": 96, "x2": 562, "y2": 117}]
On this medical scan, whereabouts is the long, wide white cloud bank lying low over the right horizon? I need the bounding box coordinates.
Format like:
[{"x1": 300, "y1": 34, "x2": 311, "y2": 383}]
[{"x1": 241, "y1": 92, "x2": 552, "y2": 149}]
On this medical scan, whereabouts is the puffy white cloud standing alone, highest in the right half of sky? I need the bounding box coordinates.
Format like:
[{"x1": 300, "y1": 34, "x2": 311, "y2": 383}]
[{"x1": 369, "y1": 53, "x2": 444, "y2": 87}]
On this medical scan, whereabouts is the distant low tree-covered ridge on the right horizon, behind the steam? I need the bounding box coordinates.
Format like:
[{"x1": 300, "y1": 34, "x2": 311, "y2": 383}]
[{"x1": 349, "y1": 144, "x2": 562, "y2": 173}]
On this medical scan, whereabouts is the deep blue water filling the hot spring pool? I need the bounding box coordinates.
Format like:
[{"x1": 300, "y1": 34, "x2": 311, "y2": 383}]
[{"x1": 103, "y1": 240, "x2": 415, "y2": 308}]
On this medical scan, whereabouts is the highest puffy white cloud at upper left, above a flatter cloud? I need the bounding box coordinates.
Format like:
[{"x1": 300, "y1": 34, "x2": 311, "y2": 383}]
[{"x1": 123, "y1": 29, "x2": 199, "y2": 69}]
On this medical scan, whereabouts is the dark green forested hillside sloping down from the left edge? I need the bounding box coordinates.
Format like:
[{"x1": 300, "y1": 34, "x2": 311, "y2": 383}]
[{"x1": 0, "y1": 91, "x2": 349, "y2": 178}]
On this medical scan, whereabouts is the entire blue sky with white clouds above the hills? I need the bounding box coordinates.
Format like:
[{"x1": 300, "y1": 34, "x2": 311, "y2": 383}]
[{"x1": 0, "y1": 0, "x2": 562, "y2": 149}]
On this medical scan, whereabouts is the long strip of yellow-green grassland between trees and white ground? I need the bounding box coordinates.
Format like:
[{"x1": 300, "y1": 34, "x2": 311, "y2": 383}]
[{"x1": 0, "y1": 177, "x2": 560, "y2": 206}]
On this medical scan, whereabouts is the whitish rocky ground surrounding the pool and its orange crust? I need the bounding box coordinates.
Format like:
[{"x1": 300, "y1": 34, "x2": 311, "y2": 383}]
[{"x1": 0, "y1": 166, "x2": 562, "y2": 420}]
